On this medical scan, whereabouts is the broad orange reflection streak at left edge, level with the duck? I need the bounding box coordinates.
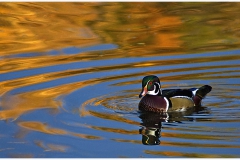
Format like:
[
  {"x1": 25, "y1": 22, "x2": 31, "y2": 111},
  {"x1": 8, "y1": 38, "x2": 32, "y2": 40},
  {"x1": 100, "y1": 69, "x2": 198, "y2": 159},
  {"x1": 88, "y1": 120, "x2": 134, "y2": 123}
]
[{"x1": 0, "y1": 81, "x2": 93, "y2": 119}]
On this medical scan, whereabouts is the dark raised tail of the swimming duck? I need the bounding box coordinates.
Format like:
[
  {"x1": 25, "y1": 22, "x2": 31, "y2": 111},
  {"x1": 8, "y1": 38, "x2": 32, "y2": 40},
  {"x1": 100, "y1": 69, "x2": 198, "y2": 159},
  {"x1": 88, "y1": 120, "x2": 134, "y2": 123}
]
[{"x1": 193, "y1": 85, "x2": 212, "y2": 105}]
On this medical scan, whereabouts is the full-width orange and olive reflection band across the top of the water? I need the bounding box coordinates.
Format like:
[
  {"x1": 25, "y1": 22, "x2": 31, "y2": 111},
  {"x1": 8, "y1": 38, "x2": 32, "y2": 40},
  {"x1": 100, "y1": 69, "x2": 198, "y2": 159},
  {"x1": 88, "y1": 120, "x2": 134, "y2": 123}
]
[{"x1": 0, "y1": 2, "x2": 240, "y2": 56}]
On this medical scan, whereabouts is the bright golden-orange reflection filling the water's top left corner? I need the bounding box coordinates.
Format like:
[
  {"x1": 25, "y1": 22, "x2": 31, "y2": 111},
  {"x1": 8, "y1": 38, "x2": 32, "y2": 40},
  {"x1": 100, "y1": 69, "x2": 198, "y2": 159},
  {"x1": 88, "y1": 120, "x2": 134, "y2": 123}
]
[{"x1": 0, "y1": 2, "x2": 100, "y2": 55}]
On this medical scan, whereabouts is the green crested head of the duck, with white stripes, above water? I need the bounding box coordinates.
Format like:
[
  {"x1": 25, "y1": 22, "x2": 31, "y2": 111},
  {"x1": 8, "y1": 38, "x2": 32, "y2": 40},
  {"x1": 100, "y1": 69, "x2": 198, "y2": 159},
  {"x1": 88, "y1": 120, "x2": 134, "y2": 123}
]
[{"x1": 139, "y1": 75, "x2": 162, "y2": 98}]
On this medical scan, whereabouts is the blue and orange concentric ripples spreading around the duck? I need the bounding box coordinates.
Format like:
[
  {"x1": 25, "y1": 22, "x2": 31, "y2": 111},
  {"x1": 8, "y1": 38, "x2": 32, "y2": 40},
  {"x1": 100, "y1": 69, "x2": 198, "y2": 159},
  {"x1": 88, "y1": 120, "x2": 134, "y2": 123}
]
[{"x1": 0, "y1": 44, "x2": 240, "y2": 157}]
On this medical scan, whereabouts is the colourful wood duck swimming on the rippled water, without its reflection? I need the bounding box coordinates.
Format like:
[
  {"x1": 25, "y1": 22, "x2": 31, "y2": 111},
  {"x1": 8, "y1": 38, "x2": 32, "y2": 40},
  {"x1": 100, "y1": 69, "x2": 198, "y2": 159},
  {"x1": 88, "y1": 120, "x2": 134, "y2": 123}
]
[{"x1": 138, "y1": 75, "x2": 212, "y2": 113}]
